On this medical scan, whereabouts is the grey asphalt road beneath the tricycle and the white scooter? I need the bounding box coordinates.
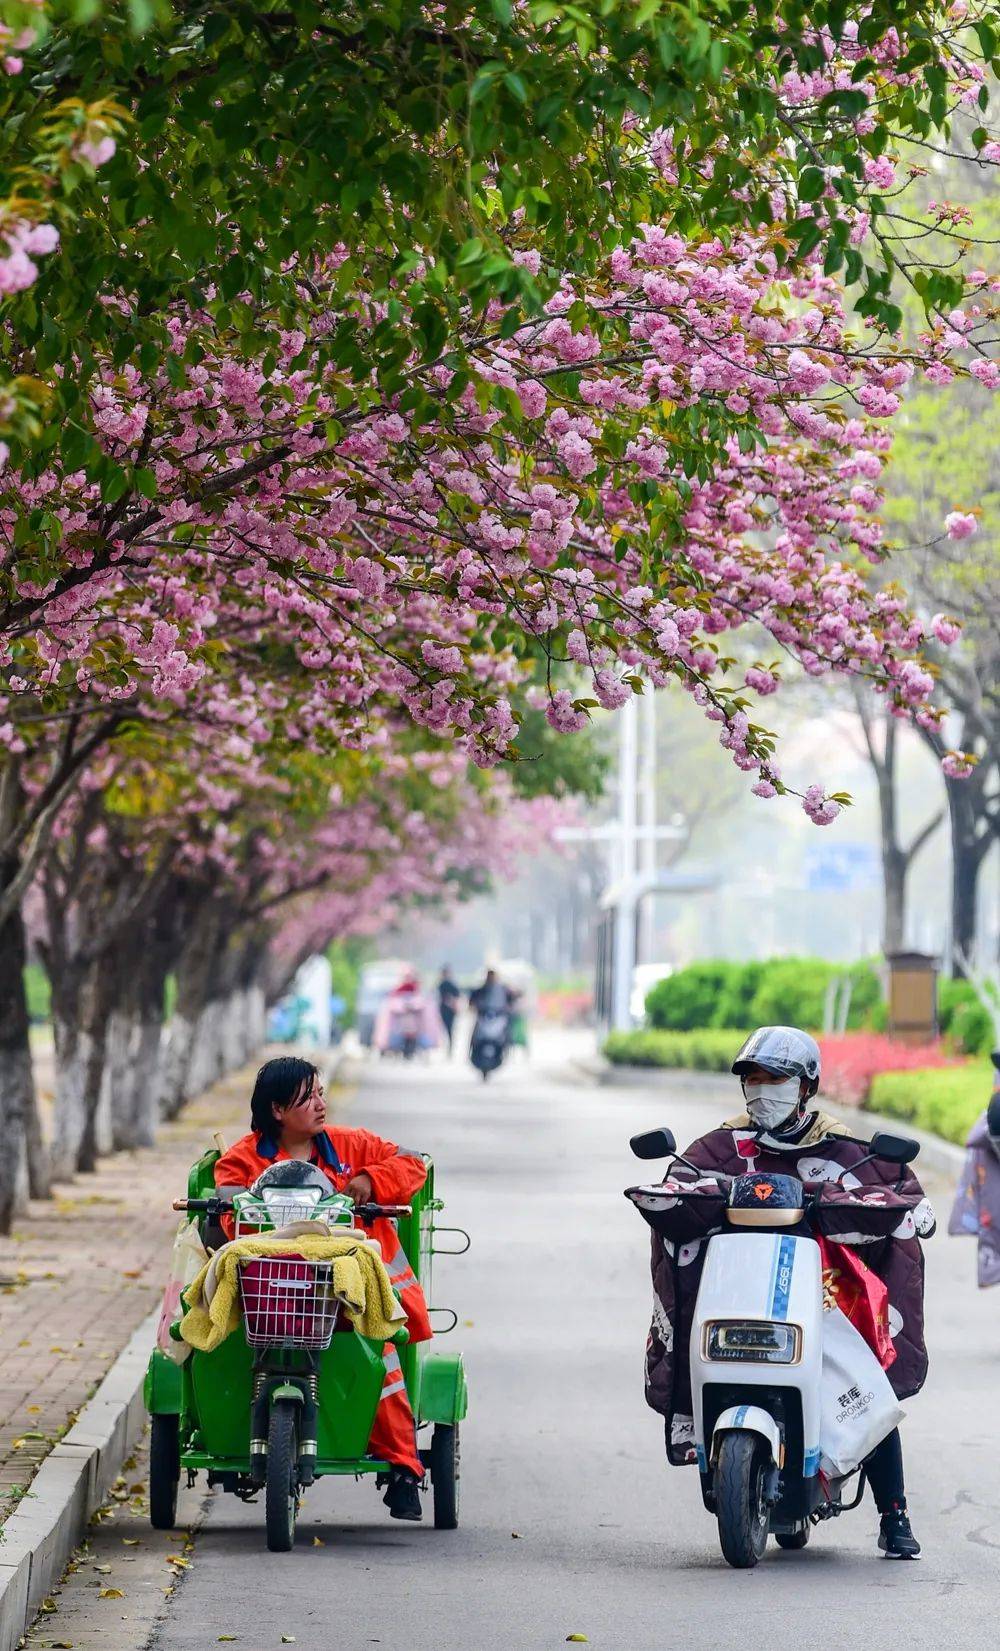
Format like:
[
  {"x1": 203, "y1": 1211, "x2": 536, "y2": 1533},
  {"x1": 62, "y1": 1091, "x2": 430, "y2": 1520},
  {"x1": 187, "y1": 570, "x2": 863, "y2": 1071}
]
[{"x1": 31, "y1": 1047, "x2": 1000, "y2": 1651}]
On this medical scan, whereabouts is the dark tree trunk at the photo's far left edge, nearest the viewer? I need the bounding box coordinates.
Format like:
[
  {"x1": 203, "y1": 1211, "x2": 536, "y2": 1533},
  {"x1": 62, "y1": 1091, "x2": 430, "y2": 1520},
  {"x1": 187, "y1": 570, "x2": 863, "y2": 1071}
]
[{"x1": 0, "y1": 884, "x2": 35, "y2": 1233}]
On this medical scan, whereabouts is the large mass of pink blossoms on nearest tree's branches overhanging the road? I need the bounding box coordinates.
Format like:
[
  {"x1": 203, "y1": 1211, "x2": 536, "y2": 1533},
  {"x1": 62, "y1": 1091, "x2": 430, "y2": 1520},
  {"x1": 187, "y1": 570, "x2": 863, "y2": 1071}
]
[{"x1": 0, "y1": 208, "x2": 992, "y2": 824}]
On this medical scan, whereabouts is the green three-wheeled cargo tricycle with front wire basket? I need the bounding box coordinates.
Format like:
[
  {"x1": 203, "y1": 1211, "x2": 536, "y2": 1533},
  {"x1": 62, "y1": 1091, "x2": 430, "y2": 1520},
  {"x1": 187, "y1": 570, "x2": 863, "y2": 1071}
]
[{"x1": 145, "y1": 1151, "x2": 469, "y2": 1552}]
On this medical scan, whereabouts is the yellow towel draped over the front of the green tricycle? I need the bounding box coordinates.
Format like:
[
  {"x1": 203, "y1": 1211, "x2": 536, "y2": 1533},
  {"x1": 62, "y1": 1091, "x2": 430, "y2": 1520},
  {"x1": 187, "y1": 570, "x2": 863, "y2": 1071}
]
[{"x1": 180, "y1": 1235, "x2": 406, "y2": 1352}]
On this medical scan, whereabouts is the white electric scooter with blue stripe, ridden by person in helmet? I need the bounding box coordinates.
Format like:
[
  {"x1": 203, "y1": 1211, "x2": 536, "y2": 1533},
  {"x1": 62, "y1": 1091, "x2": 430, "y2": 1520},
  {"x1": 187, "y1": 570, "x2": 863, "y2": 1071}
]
[{"x1": 625, "y1": 1129, "x2": 919, "y2": 1568}]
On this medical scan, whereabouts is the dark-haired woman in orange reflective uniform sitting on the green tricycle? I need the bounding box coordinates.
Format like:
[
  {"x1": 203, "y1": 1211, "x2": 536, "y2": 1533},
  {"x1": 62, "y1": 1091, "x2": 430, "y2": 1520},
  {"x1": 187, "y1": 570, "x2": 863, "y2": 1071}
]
[{"x1": 215, "y1": 1055, "x2": 431, "y2": 1519}]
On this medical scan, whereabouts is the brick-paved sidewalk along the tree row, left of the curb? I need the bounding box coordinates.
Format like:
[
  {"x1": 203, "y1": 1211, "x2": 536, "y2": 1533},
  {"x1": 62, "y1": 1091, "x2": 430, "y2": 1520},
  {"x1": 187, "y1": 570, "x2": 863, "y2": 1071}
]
[{"x1": 0, "y1": 1063, "x2": 256, "y2": 1521}]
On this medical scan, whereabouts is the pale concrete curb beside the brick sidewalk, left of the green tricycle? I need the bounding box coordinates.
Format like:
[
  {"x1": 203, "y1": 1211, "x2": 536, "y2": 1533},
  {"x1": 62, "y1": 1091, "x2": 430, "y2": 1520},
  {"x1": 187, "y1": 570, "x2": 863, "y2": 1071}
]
[{"x1": 0, "y1": 1308, "x2": 158, "y2": 1651}]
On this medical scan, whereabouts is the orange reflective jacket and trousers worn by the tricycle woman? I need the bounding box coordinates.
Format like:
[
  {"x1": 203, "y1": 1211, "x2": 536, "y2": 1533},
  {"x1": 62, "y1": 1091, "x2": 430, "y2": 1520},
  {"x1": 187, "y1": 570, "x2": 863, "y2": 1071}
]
[{"x1": 215, "y1": 1128, "x2": 431, "y2": 1476}]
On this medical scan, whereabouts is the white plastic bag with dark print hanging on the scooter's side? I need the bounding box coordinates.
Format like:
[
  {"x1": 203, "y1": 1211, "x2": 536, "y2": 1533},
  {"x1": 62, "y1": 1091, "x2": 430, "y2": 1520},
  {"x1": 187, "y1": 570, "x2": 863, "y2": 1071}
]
[{"x1": 820, "y1": 1308, "x2": 903, "y2": 1478}]
